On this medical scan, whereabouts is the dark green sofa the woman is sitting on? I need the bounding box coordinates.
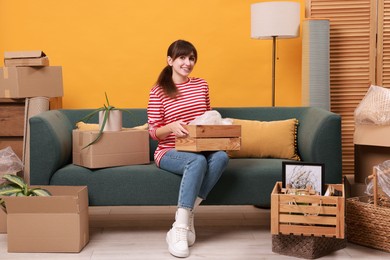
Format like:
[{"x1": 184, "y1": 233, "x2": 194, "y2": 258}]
[{"x1": 29, "y1": 107, "x2": 342, "y2": 207}]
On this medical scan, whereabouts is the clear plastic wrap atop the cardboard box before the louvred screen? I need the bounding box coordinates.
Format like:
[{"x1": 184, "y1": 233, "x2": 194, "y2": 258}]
[{"x1": 355, "y1": 85, "x2": 390, "y2": 125}]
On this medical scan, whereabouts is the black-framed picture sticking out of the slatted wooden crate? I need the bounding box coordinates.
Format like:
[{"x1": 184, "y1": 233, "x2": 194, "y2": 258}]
[{"x1": 282, "y1": 161, "x2": 325, "y2": 195}]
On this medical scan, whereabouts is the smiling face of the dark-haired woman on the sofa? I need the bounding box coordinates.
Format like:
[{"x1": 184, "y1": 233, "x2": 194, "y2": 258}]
[{"x1": 167, "y1": 52, "x2": 196, "y2": 84}]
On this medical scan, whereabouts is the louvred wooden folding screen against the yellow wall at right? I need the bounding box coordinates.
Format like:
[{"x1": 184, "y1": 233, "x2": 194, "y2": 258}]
[{"x1": 306, "y1": 0, "x2": 390, "y2": 177}]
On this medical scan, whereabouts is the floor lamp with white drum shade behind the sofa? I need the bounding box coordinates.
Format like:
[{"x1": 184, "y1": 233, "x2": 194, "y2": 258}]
[{"x1": 251, "y1": 2, "x2": 300, "y2": 106}]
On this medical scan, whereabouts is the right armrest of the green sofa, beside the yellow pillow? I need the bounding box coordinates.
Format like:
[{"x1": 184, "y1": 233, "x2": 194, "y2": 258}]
[{"x1": 298, "y1": 107, "x2": 342, "y2": 183}]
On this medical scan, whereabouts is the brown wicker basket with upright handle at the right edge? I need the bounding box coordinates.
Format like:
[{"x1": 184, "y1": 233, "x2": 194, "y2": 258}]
[{"x1": 346, "y1": 169, "x2": 390, "y2": 252}]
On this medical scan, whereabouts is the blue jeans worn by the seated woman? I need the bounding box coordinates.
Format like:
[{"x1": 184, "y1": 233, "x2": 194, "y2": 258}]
[{"x1": 160, "y1": 149, "x2": 229, "y2": 209}]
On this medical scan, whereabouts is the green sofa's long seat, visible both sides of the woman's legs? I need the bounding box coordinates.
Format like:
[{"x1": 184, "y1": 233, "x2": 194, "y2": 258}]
[{"x1": 50, "y1": 158, "x2": 283, "y2": 207}]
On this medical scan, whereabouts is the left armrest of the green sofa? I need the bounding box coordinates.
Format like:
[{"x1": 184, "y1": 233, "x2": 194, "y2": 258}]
[{"x1": 29, "y1": 110, "x2": 73, "y2": 185}]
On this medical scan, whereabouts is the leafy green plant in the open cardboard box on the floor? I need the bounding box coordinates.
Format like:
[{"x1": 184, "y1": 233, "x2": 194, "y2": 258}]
[{"x1": 0, "y1": 174, "x2": 51, "y2": 208}]
